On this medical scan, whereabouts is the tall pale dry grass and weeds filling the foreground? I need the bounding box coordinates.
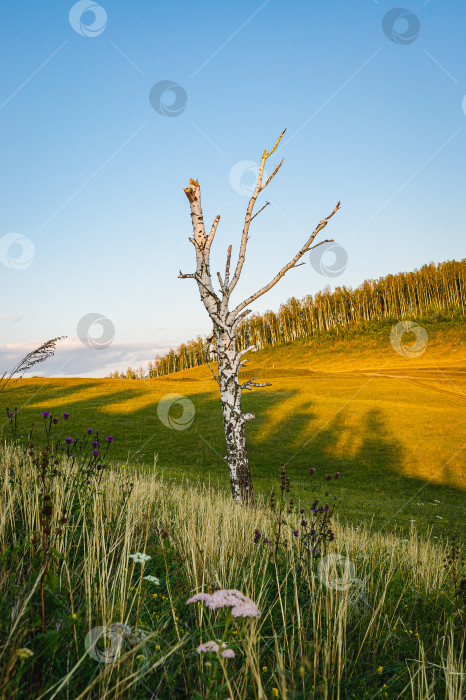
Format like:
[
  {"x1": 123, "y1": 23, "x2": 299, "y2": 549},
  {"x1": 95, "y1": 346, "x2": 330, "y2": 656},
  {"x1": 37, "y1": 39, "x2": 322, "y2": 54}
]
[{"x1": 0, "y1": 443, "x2": 466, "y2": 700}]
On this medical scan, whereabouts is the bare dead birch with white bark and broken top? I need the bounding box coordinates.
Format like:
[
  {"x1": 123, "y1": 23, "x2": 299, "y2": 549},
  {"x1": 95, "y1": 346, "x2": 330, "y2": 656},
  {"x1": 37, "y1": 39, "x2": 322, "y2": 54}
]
[{"x1": 179, "y1": 132, "x2": 340, "y2": 504}]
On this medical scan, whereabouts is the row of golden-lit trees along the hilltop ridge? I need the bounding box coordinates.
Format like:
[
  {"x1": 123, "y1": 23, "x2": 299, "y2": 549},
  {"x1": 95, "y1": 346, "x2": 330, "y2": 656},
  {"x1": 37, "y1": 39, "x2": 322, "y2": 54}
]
[{"x1": 109, "y1": 259, "x2": 466, "y2": 379}]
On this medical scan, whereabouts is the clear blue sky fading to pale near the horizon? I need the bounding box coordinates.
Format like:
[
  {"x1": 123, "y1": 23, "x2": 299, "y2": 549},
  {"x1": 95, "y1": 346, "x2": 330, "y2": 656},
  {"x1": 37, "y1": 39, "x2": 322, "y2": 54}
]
[{"x1": 0, "y1": 0, "x2": 466, "y2": 377}]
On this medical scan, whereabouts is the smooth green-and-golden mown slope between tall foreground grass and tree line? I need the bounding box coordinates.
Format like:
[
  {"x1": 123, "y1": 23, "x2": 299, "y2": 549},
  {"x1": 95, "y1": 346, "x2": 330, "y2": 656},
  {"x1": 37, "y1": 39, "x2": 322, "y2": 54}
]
[{"x1": 2, "y1": 319, "x2": 466, "y2": 536}]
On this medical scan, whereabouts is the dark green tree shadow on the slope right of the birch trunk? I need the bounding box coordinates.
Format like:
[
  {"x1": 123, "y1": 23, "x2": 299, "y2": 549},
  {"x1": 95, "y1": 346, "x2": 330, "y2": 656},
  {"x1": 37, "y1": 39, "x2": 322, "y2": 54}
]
[{"x1": 244, "y1": 394, "x2": 466, "y2": 536}]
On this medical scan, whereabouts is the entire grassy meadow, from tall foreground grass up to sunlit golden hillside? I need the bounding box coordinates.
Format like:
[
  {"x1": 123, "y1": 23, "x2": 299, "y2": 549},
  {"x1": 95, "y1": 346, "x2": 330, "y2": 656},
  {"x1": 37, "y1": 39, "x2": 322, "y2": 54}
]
[{"x1": 0, "y1": 314, "x2": 466, "y2": 700}]
